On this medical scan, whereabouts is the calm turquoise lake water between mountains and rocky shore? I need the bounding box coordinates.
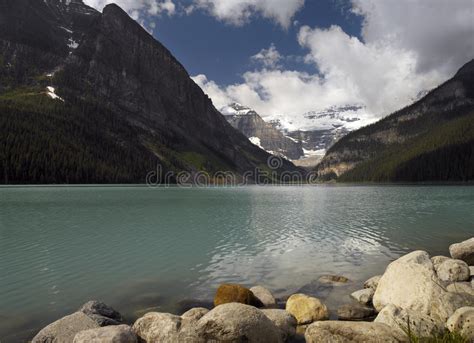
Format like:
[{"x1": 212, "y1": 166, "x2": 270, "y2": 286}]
[{"x1": 0, "y1": 186, "x2": 474, "y2": 343}]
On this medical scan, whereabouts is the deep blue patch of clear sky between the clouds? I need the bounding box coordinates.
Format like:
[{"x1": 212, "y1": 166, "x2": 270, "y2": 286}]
[{"x1": 150, "y1": 0, "x2": 362, "y2": 85}]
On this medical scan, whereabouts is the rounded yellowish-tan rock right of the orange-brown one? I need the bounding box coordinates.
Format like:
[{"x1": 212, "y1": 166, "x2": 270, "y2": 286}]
[{"x1": 286, "y1": 294, "x2": 329, "y2": 325}]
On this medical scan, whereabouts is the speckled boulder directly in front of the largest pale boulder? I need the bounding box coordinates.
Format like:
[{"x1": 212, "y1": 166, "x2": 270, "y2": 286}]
[{"x1": 374, "y1": 305, "x2": 444, "y2": 337}]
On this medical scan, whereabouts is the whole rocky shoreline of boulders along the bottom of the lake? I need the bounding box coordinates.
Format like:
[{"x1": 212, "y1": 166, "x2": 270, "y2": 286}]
[{"x1": 32, "y1": 238, "x2": 474, "y2": 343}]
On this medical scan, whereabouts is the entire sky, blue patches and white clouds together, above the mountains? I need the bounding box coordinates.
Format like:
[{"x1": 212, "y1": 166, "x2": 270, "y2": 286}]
[{"x1": 84, "y1": 0, "x2": 474, "y2": 125}]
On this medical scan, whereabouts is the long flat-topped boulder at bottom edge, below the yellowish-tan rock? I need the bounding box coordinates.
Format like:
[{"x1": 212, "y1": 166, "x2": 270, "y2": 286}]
[{"x1": 304, "y1": 321, "x2": 404, "y2": 343}]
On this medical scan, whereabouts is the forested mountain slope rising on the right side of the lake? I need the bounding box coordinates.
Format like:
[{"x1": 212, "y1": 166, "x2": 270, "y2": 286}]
[{"x1": 316, "y1": 60, "x2": 474, "y2": 182}]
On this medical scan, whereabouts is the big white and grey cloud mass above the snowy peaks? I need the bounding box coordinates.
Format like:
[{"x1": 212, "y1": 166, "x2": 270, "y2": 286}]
[{"x1": 195, "y1": 0, "x2": 474, "y2": 123}]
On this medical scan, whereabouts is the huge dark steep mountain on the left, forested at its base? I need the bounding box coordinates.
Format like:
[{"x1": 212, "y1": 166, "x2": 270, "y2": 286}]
[{"x1": 0, "y1": 0, "x2": 296, "y2": 183}]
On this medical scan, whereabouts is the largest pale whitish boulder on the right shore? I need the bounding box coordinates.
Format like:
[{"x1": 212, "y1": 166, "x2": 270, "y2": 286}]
[{"x1": 373, "y1": 251, "x2": 472, "y2": 322}]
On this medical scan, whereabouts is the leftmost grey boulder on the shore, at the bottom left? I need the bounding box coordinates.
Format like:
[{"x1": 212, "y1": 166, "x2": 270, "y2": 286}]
[{"x1": 32, "y1": 312, "x2": 100, "y2": 343}]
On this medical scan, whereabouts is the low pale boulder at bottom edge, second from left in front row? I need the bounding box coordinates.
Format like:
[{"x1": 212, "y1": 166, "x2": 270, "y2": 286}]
[{"x1": 73, "y1": 325, "x2": 138, "y2": 343}]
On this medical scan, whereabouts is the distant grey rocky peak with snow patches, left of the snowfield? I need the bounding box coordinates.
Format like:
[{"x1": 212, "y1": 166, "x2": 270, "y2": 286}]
[{"x1": 221, "y1": 103, "x2": 304, "y2": 160}]
